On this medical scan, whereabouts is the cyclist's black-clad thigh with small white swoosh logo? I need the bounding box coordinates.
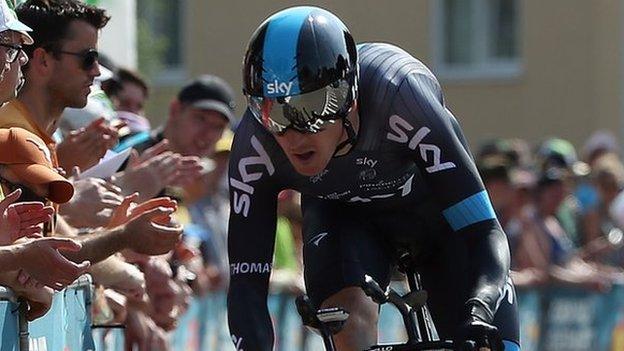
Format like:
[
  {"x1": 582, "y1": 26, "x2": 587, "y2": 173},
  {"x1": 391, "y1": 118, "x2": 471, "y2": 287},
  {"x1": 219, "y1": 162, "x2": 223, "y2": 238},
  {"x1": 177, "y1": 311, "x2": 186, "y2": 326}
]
[{"x1": 302, "y1": 196, "x2": 390, "y2": 306}]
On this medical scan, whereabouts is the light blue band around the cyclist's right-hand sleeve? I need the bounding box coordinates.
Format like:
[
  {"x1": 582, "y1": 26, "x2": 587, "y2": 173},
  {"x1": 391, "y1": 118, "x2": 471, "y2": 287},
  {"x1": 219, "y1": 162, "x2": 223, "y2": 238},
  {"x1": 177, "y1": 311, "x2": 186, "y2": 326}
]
[{"x1": 442, "y1": 190, "x2": 496, "y2": 231}]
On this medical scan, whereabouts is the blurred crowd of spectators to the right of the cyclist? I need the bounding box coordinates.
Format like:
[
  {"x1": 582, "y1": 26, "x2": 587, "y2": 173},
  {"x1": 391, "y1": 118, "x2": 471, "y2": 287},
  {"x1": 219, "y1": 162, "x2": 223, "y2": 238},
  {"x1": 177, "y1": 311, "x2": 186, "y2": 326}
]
[{"x1": 477, "y1": 131, "x2": 624, "y2": 291}]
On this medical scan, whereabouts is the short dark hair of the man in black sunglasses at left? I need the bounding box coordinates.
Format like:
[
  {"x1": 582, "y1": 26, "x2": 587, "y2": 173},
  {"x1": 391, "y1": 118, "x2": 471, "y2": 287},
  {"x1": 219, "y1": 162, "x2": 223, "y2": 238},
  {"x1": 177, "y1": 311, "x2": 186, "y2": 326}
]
[{"x1": 16, "y1": 0, "x2": 110, "y2": 58}]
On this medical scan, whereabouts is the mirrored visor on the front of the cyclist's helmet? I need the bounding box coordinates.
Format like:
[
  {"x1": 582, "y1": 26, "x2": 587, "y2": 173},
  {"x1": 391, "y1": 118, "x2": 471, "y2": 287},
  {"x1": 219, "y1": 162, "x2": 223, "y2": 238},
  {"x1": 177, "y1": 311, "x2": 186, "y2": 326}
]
[{"x1": 247, "y1": 80, "x2": 351, "y2": 135}]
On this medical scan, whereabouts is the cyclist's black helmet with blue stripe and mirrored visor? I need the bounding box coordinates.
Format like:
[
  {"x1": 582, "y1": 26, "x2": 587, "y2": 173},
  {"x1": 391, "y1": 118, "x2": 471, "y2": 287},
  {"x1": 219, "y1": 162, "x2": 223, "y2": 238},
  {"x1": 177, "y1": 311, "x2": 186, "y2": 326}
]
[{"x1": 243, "y1": 6, "x2": 358, "y2": 134}]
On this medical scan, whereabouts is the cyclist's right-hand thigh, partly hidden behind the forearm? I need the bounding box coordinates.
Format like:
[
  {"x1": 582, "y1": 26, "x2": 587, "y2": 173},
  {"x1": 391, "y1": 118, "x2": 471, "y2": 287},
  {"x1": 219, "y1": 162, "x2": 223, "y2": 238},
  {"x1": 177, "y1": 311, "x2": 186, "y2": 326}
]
[{"x1": 419, "y1": 232, "x2": 519, "y2": 351}]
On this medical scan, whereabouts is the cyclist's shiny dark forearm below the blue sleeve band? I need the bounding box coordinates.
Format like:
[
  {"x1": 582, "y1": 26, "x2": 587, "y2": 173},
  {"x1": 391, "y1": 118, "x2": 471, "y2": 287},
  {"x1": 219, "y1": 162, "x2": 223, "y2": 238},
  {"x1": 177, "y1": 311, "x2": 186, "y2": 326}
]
[{"x1": 458, "y1": 220, "x2": 510, "y2": 322}]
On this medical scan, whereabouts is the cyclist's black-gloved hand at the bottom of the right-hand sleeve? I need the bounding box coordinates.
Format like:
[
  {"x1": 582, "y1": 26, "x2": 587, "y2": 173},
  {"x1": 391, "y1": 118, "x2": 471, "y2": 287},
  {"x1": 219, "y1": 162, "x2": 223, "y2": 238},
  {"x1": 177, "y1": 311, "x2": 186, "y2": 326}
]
[{"x1": 454, "y1": 317, "x2": 505, "y2": 351}]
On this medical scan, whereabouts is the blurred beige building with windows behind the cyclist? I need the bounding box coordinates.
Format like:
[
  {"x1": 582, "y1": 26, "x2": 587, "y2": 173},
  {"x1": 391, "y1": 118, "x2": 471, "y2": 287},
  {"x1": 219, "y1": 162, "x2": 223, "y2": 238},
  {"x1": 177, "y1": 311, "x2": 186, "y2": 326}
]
[{"x1": 135, "y1": 0, "x2": 624, "y2": 144}]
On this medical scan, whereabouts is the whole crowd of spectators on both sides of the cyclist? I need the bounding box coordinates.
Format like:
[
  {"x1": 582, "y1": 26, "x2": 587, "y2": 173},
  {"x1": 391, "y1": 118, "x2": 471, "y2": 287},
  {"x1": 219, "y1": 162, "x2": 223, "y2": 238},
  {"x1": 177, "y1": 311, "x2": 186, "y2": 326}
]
[{"x1": 0, "y1": 0, "x2": 624, "y2": 350}]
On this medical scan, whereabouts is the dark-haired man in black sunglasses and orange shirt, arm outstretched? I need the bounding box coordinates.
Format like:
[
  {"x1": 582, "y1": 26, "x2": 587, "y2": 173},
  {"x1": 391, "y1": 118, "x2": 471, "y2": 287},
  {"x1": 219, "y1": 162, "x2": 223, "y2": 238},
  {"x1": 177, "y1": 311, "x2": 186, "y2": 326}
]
[{"x1": 0, "y1": 0, "x2": 181, "y2": 262}]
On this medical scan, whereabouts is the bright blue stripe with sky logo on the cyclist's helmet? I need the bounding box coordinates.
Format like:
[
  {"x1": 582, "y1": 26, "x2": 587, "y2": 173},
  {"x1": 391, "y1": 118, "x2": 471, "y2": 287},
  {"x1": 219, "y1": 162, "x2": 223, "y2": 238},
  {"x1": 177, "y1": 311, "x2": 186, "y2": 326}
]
[{"x1": 262, "y1": 6, "x2": 314, "y2": 97}]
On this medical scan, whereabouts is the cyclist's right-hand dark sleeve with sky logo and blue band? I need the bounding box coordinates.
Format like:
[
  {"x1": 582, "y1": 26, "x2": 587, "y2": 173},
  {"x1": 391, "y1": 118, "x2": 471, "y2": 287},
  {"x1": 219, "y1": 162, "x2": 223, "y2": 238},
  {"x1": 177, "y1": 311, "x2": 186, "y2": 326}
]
[{"x1": 388, "y1": 72, "x2": 510, "y2": 322}]
